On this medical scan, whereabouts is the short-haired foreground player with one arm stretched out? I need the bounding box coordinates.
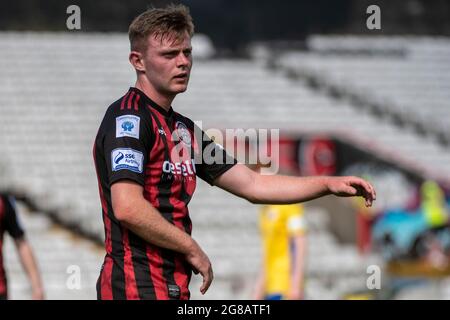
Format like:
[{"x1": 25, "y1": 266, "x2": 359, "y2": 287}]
[{"x1": 93, "y1": 5, "x2": 375, "y2": 299}]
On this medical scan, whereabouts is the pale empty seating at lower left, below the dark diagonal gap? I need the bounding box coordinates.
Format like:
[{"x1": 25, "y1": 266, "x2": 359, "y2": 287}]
[{"x1": 3, "y1": 202, "x2": 104, "y2": 300}]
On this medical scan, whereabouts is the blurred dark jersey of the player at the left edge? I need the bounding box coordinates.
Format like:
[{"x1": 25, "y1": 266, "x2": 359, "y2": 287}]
[{"x1": 0, "y1": 195, "x2": 24, "y2": 297}]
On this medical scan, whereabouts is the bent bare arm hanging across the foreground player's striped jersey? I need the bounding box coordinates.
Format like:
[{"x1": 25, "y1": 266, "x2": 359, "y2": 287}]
[{"x1": 111, "y1": 180, "x2": 213, "y2": 294}]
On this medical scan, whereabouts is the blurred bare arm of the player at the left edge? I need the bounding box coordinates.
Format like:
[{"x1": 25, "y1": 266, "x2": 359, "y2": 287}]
[{"x1": 15, "y1": 238, "x2": 44, "y2": 300}]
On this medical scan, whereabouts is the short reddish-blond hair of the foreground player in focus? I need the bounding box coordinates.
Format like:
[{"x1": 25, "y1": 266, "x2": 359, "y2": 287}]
[{"x1": 128, "y1": 4, "x2": 194, "y2": 52}]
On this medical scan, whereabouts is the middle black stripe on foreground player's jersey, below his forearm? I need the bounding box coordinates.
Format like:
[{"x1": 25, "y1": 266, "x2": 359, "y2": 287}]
[{"x1": 128, "y1": 231, "x2": 156, "y2": 300}]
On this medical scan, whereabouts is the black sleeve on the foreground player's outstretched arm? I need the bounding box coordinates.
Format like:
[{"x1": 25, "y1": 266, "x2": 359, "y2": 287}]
[{"x1": 195, "y1": 128, "x2": 237, "y2": 185}]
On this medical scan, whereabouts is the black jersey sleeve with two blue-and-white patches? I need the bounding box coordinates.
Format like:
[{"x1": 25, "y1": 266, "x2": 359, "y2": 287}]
[{"x1": 103, "y1": 109, "x2": 154, "y2": 186}]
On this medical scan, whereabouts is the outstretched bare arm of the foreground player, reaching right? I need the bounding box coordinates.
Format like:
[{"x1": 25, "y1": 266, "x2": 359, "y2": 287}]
[{"x1": 215, "y1": 164, "x2": 376, "y2": 206}]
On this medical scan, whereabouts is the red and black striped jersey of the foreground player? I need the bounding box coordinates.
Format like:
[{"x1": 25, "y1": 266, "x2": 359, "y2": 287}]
[{"x1": 94, "y1": 88, "x2": 236, "y2": 299}]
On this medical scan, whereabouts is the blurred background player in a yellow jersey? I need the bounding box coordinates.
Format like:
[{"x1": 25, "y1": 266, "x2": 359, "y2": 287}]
[{"x1": 255, "y1": 204, "x2": 306, "y2": 300}]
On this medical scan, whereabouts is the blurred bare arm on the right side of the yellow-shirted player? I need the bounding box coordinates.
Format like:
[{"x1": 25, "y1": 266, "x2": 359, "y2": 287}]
[{"x1": 288, "y1": 235, "x2": 306, "y2": 300}]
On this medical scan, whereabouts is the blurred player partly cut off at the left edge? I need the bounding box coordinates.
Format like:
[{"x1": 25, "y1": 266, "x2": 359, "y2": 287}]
[{"x1": 0, "y1": 194, "x2": 44, "y2": 300}]
